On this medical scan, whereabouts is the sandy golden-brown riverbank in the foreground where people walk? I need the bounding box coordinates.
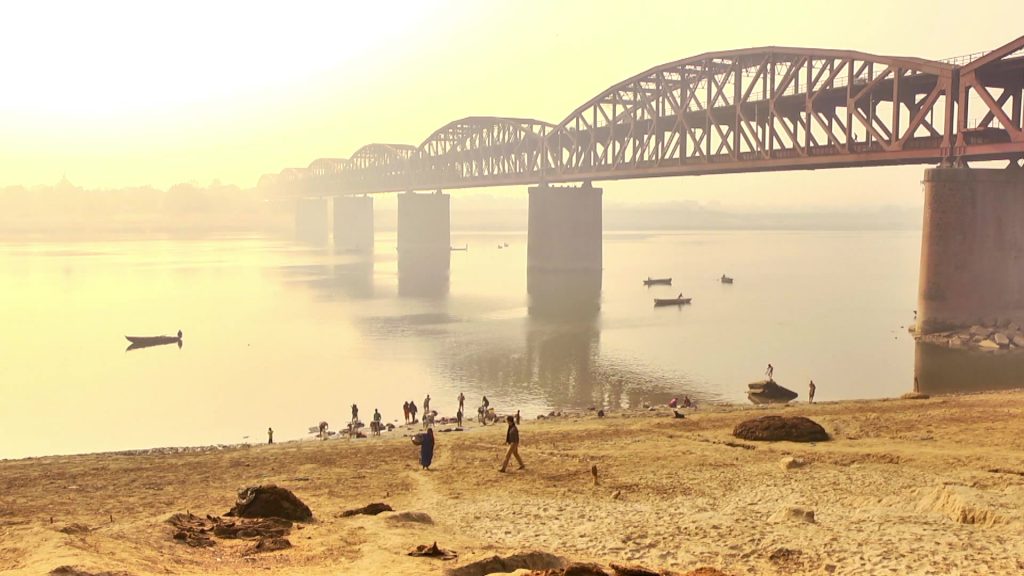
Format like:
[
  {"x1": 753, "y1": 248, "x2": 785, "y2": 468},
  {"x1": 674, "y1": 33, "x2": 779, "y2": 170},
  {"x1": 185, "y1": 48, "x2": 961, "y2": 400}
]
[{"x1": 0, "y1": 392, "x2": 1024, "y2": 576}]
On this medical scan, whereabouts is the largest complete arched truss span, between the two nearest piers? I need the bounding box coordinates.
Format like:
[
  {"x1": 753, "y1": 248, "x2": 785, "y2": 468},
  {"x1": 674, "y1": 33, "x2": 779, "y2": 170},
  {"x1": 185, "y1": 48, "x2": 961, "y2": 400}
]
[{"x1": 548, "y1": 46, "x2": 955, "y2": 179}]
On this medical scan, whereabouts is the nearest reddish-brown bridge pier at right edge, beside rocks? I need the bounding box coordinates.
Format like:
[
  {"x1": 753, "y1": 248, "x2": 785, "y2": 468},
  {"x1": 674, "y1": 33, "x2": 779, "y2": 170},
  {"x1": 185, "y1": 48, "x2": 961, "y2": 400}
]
[{"x1": 918, "y1": 167, "x2": 1024, "y2": 334}]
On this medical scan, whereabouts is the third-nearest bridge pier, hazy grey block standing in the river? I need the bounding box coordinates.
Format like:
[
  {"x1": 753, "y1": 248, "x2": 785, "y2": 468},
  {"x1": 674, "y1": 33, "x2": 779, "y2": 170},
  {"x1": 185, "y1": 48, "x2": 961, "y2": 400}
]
[{"x1": 398, "y1": 191, "x2": 452, "y2": 297}]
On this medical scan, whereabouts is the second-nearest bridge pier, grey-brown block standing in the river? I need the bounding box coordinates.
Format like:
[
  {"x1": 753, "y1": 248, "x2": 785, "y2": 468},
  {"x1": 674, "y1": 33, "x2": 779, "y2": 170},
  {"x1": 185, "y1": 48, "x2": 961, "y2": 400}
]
[{"x1": 526, "y1": 182, "x2": 603, "y2": 316}]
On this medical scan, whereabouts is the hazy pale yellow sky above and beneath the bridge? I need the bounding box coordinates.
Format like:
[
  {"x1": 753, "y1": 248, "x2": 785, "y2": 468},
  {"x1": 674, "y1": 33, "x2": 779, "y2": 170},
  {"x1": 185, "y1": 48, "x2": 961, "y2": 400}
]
[{"x1": 0, "y1": 0, "x2": 1024, "y2": 207}]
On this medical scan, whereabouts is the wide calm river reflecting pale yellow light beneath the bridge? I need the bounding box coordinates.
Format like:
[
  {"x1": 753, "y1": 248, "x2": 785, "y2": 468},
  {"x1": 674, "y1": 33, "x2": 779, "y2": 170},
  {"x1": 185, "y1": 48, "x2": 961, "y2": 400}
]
[{"x1": 0, "y1": 226, "x2": 1011, "y2": 458}]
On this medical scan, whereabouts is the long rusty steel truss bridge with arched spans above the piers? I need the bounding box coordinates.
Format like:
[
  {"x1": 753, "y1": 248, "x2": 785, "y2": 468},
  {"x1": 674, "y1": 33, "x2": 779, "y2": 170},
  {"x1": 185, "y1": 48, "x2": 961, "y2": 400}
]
[{"x1": 259, "y1": 37, "x2": 1024, "y2": 196}]
